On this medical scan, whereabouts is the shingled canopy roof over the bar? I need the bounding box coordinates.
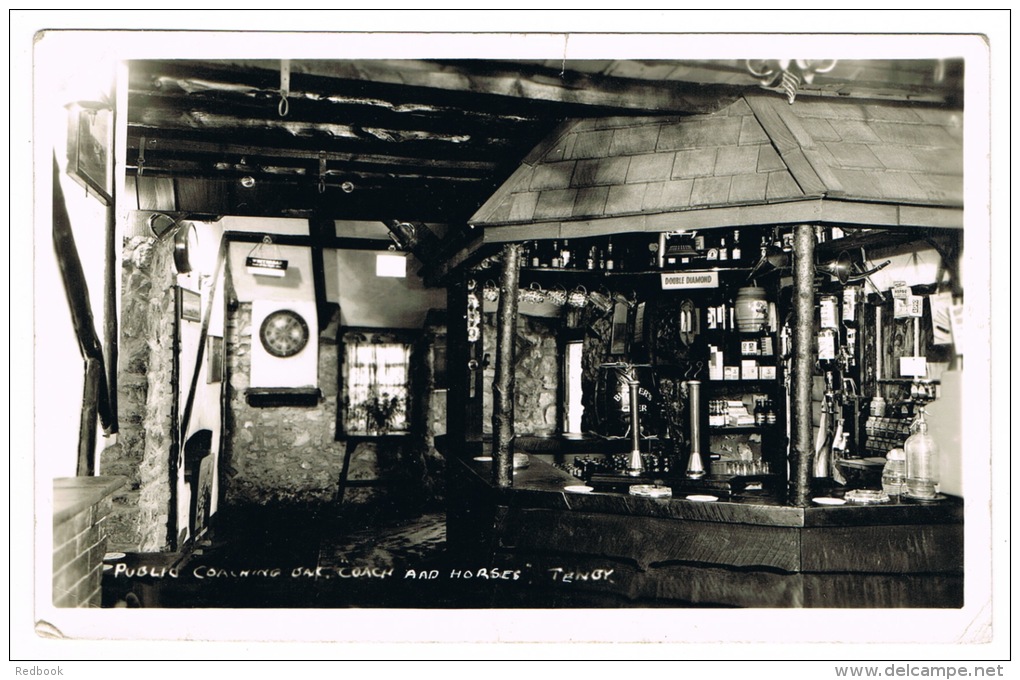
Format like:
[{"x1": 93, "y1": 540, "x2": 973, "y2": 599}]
[{"x1": 469, "y1": 95, "x2": 963, "y2": 232}]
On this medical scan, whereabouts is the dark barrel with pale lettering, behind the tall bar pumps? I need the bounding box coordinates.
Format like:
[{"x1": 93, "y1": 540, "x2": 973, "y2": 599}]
[{"x1": 595, "y1": 363, "x2": 661, "y2": 437}]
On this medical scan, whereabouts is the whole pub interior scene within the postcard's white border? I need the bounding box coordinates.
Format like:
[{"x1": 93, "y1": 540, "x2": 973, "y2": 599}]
[{"x1": 37, "y1": 46, "x2": 969, "y2": 609}]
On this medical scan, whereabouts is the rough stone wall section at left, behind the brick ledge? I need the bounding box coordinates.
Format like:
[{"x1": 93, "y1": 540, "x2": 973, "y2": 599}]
[{"x1": 100, "y1": 237, "x2": 176, "y2": 552}]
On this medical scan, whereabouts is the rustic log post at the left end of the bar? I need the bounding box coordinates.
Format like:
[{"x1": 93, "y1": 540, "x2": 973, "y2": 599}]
[{"x1": 493, "y1": 244, "x2": 522, "y2": 488}]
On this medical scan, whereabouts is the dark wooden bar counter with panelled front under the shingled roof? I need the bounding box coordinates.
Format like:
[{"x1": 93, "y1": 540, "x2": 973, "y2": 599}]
[{"x1": 439, "y1": 437, "x2": 964, "y2": 608}]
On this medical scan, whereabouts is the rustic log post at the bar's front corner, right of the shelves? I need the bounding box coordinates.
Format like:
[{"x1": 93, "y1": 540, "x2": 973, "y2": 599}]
[{"x1": 789, "y1": 224, "x2": 815, "y2": 507}]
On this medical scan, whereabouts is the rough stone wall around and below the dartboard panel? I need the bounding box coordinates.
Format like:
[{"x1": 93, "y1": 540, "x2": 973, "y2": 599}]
[{"x1": 221, "y1": 303, "x2": 344, "y2": 509}]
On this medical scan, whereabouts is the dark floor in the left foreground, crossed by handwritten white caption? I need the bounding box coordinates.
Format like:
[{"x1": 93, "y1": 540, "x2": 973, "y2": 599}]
[{"x1": 103, "y1": 511, "x2": 571, "y2": 609}]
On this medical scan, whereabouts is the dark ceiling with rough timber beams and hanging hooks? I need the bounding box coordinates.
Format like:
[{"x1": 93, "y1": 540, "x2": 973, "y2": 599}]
[{"x1": 126, "y1": 59, "x2": 962, "y2": 231}]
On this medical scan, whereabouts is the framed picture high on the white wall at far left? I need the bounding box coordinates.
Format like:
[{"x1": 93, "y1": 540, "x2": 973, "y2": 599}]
[{"x1": 67, "y1": 102, "x2": 113, "y2": 205}]
